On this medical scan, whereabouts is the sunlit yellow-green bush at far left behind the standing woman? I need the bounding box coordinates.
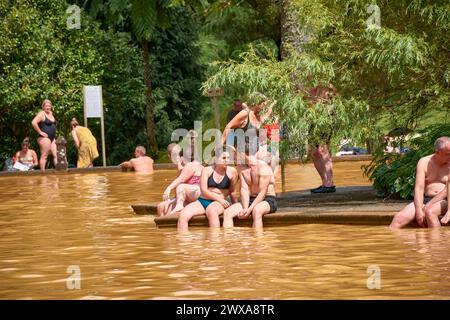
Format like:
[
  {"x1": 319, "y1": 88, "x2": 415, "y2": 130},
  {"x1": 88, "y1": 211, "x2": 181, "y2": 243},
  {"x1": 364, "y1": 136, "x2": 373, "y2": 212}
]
[{"x1": 0, "y1": 0, "x2": 104, "y2": 165}]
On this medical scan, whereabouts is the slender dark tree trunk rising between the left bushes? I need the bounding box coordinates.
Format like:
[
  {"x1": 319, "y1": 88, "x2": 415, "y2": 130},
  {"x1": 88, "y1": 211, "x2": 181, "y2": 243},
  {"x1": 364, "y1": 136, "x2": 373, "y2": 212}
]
[{"x1": 142, "y1": 40, "x2": 158, "y2": 152}]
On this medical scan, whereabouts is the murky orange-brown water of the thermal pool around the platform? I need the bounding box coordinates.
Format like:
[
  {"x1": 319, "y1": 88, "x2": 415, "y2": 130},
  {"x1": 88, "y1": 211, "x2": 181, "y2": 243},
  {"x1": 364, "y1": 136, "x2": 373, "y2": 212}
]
[{"x1": 0, "y1": 162, "x2": 450, "y2": 299}]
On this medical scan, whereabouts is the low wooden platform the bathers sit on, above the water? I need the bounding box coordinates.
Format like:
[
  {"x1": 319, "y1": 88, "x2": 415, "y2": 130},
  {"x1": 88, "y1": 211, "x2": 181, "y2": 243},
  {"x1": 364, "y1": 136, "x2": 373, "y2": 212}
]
[{"x1": 132, "y1": 187, "x2": 414, "y2": 228}]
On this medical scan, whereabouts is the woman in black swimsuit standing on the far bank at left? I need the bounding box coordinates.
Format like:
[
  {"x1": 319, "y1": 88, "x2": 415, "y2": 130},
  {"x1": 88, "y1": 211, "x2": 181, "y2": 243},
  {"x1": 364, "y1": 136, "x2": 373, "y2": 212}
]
[{"x1": 31, "y1": 99, "x2": 56, "y2": 171}]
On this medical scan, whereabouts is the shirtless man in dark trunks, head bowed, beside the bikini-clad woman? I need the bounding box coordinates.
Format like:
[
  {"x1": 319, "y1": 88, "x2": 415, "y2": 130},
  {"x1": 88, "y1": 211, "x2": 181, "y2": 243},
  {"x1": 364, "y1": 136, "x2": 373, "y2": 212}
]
[{"x1": 223, "y1": 156, "x2": 277, "y2": 228}]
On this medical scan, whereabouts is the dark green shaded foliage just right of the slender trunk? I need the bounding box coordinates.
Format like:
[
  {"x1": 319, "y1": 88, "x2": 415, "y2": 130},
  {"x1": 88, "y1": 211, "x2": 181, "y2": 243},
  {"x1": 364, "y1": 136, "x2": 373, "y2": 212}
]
[{"x1": 151, "y1": 8, "x2": 207, "y2": 147}]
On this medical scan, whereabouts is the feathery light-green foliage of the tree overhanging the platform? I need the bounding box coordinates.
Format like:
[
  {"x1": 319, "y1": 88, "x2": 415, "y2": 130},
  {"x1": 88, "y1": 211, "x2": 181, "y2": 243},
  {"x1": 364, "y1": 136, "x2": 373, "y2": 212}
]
[{"x1": 203, "y1": 0, "x2": 450, "y2": 161}]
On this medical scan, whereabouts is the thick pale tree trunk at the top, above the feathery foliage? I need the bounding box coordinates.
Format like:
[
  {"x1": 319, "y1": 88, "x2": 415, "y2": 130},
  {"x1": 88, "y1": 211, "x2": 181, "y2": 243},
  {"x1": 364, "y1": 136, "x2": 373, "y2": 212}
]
[{"x1": 280, "y1": 0, "x2": 309, "y2": 60}]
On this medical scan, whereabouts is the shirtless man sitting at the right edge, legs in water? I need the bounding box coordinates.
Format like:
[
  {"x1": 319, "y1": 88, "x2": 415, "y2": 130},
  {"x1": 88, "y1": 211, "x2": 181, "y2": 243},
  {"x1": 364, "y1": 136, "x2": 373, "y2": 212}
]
[{"x1": 390, "y1": 137, "x2": 450, "y2": 229}]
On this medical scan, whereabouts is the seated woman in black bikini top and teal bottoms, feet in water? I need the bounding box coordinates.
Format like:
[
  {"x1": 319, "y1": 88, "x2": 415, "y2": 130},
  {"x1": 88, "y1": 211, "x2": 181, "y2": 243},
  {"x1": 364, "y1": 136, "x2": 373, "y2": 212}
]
[{"x1": 178, "y1": 149, "x2": 239, "y2": 231}]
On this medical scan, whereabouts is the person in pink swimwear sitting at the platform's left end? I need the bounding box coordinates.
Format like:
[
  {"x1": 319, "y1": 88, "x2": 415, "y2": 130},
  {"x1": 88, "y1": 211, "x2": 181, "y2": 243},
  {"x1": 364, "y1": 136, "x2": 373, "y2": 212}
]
[{"x1": 157, "y1": 145, "x2": 203, "y2": 216}]
